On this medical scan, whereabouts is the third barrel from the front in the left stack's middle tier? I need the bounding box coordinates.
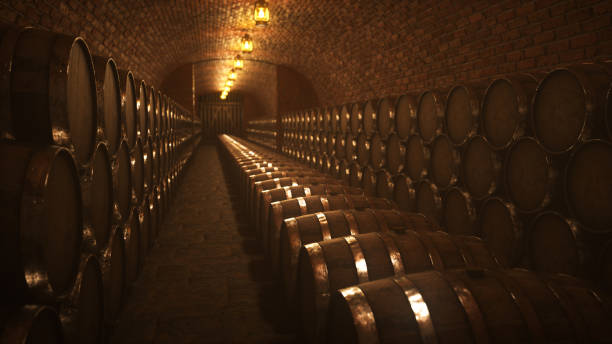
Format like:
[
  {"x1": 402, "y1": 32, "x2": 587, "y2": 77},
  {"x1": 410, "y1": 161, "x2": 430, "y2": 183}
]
[{"x1": 113, "y1": 140, "x2": 132, "y2": 221}]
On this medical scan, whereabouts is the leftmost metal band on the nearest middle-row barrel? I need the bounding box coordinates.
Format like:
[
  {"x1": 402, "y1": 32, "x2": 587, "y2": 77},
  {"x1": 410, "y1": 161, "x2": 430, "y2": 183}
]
[{"x1": 339, "y1": 287, "x2": 380, "y2": 344}]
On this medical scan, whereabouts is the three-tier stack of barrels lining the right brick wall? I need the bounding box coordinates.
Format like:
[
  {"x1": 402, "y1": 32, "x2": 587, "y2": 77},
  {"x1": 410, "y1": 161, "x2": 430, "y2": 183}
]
[{"x1": 280, "y1": 61, "x2": 612, "y2": 288}]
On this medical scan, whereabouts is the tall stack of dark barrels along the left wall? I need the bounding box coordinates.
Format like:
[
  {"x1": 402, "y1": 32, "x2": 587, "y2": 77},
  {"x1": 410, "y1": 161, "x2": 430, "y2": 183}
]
[{"x1": 0, "y1": 26, "x2": 199, "y2": 343}]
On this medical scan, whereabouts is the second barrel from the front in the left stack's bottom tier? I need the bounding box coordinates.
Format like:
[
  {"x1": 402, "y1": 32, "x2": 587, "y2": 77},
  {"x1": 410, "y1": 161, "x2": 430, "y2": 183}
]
[{"x1": 59, "y1": 255, "x2": 105, "y2": 344}]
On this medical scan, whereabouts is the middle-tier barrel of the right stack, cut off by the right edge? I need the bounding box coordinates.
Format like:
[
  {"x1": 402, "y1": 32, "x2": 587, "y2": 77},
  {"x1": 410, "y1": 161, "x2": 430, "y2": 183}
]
[{"x1": 565, "y1": 140, "x2": 612, "y2": 233}]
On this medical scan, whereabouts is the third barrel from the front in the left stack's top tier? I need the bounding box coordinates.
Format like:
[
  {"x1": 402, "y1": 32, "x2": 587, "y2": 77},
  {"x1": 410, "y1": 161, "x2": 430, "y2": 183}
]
[{"x1": 119, "y1": 70, "x2": 138, "y2": 149}]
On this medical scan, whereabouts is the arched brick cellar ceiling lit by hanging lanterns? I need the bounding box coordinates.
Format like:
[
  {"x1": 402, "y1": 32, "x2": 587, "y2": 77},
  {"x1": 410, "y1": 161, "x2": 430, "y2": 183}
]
[{"x1": 0, "y1": 0, "x2": 612, "y2": 104}]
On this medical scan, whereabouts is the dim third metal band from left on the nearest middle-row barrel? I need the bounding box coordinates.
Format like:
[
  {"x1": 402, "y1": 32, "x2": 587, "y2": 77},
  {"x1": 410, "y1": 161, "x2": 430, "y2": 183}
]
[{"x1": 439, "y1": 272, "x2": 490, "y2": 344}]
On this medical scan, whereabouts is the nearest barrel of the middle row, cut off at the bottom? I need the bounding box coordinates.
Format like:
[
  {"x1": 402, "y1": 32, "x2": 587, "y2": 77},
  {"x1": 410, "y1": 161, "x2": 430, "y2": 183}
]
[{"x1": 327, "y1": 269, "x2": 612, "y2": 343}]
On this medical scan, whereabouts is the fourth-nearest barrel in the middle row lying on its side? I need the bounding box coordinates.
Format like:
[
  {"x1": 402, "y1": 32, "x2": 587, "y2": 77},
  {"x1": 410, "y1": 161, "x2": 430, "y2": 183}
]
[{"x1": 268, "y1": 195, "x2": 395, "y2": 273}]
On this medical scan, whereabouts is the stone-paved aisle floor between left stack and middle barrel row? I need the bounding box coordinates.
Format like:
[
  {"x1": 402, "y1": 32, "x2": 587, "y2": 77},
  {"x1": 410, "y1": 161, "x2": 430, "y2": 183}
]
[{"x1": 111, "y1": 145, "x2": 293, "y2": 344}]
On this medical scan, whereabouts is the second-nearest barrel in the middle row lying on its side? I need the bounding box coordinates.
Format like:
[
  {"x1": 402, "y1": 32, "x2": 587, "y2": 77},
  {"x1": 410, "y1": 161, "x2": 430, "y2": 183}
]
[{"x1": 297, "y1": 230, "x2": 499, "y2": 343}]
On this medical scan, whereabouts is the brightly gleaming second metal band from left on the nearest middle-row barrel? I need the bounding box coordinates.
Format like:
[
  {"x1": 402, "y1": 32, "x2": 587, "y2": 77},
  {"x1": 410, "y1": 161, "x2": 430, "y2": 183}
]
[{"x1": 393, "y1": 276, "x2": 438, "y2": 344}]
